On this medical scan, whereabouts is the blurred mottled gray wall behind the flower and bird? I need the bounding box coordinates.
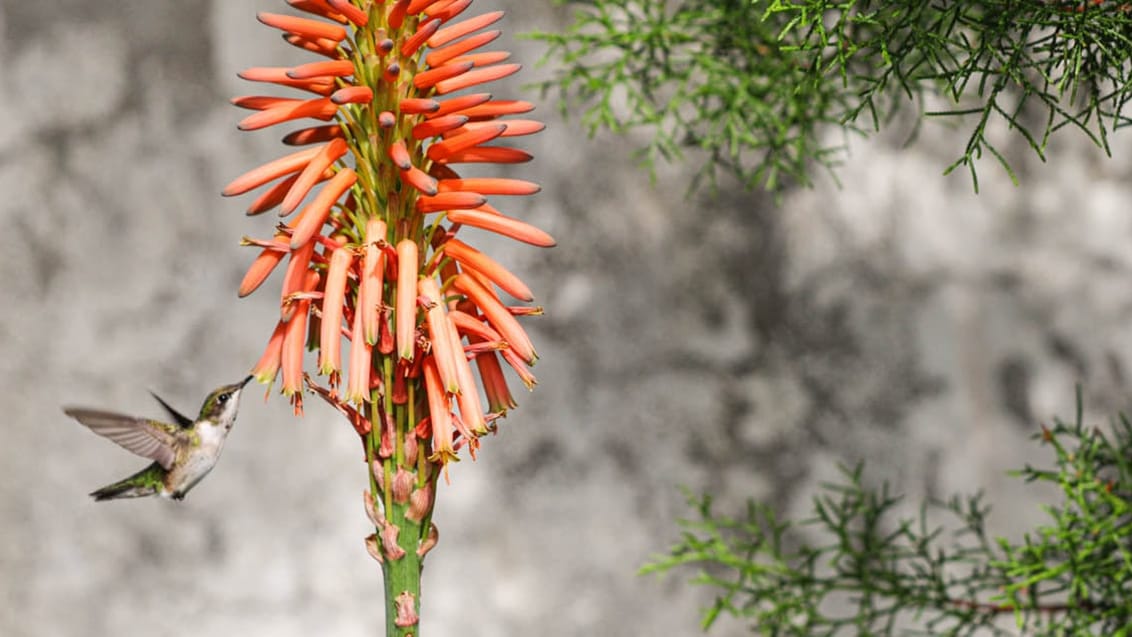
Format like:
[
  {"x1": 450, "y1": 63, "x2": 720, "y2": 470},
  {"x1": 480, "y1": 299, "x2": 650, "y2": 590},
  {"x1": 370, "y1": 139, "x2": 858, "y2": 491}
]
[{"x1": 0, "y1": 0, "x2": 1132, "y2": 637}]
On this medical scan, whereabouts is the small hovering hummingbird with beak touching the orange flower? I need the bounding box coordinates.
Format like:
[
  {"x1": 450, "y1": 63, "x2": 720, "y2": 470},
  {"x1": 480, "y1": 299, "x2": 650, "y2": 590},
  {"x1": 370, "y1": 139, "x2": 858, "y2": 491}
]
[{"x1": 63, "y1": 376, "x2": 252, "y2": 501}]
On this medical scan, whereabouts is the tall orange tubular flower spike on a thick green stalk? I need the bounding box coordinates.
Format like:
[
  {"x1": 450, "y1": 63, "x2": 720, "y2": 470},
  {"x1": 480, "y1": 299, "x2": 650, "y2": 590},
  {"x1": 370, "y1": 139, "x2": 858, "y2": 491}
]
[{"x1": 223, "y1": 0, "x2": 555, "y2": 637}]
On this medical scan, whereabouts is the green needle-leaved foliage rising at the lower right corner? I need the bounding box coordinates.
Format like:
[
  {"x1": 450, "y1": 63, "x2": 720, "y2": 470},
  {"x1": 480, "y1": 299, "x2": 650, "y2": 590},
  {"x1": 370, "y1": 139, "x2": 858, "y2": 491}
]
[{"x1": 643, "y1": 391, "x2": 1132, "y2": 637}]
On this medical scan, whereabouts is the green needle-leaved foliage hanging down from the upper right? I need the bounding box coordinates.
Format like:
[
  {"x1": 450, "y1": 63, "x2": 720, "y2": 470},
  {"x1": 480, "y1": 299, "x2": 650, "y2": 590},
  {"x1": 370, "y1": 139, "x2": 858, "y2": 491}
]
[{"x1": 533, "y1": 0, "x2": 1132, "y2": 191}]
